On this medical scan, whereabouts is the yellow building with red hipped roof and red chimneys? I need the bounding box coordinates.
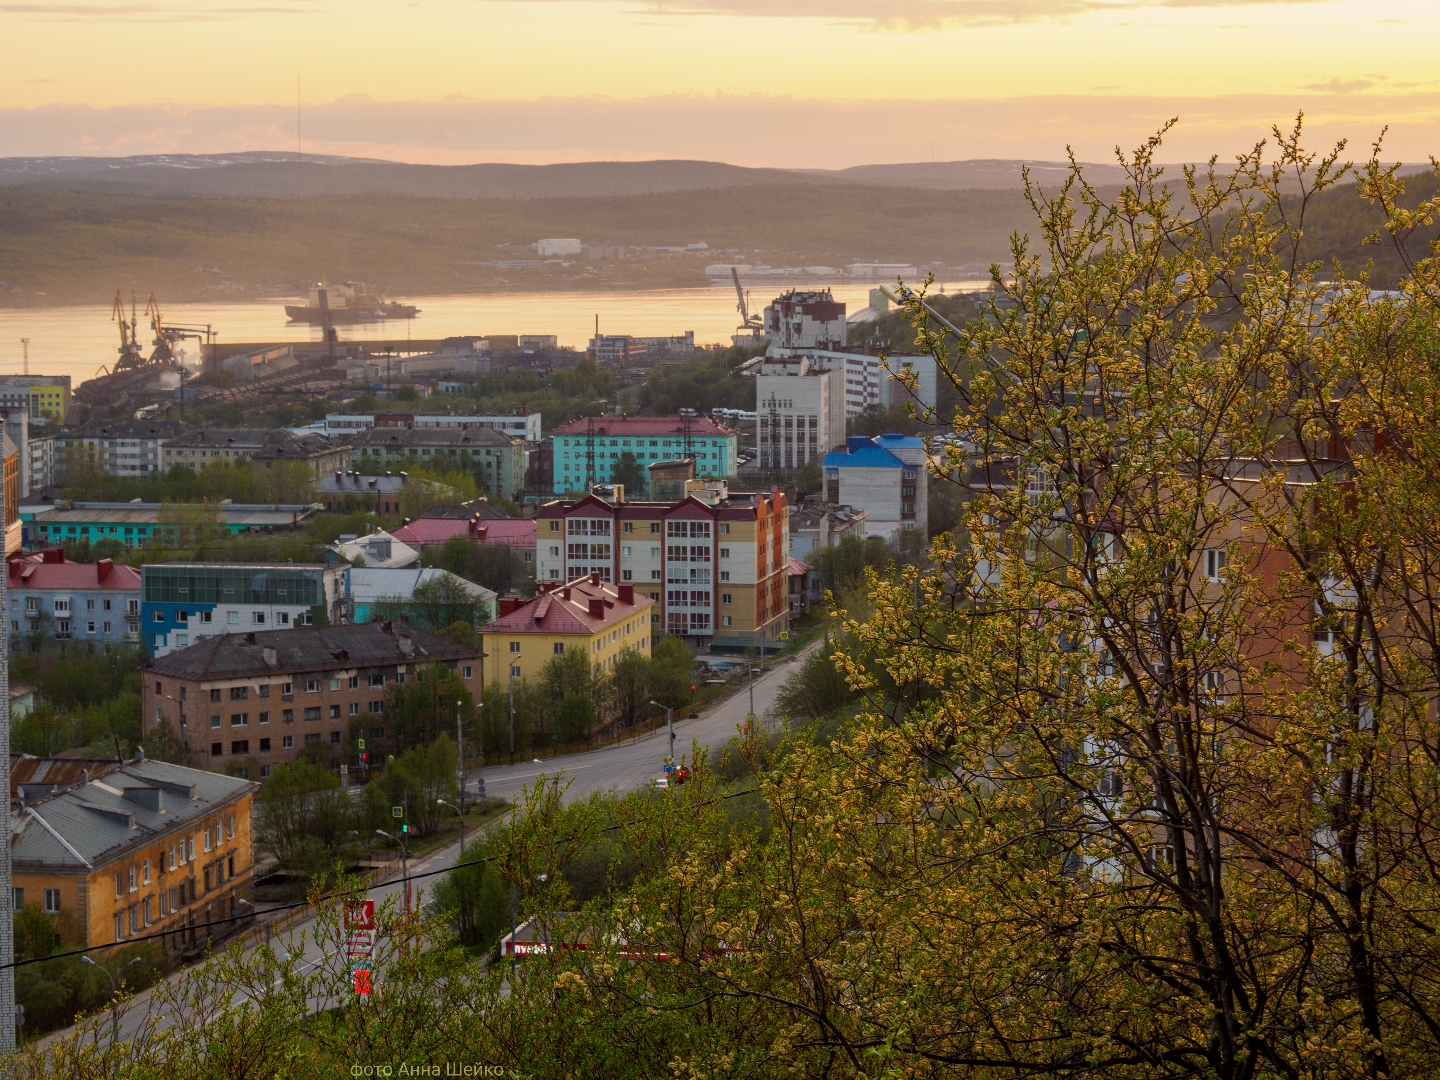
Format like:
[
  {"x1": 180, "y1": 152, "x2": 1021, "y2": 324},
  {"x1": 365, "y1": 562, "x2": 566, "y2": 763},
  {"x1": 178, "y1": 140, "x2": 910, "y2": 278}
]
[{"x1": 484, "y1": 573, "x2": 655, "y2": 685}]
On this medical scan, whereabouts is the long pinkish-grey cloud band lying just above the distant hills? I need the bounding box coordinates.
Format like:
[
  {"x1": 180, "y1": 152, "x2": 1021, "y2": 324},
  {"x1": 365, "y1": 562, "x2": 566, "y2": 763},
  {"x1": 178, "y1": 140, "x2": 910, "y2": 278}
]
[{"x1": 8, "y1": 89, "x2": 1440, "y2": 168}]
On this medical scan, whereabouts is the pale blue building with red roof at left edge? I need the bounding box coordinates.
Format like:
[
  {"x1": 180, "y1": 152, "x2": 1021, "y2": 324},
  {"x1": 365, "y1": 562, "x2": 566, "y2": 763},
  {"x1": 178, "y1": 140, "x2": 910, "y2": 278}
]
[{"x1": 6, "y1": 547, "x2": 141, "y2": 645}]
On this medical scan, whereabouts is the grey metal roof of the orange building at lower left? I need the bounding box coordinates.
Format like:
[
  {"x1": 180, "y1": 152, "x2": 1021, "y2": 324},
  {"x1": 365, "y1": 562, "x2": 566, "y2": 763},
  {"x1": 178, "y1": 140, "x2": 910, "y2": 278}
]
[{"x1": 10, "y1": 755, "x2": 259, "y2": 870}]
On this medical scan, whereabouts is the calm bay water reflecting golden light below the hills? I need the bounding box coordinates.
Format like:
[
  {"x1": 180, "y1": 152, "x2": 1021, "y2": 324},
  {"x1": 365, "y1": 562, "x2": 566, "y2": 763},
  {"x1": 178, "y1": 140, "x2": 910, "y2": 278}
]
[{"x1": 0, "y1": 282, "x2": 985, "y2": 386}]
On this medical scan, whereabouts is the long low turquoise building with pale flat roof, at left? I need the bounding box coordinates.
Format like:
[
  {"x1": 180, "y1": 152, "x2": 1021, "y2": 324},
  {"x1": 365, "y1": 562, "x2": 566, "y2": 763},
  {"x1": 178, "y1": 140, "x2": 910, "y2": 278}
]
[{"x1": 20, "y1": 501, "x2": 315, "y2": 547}]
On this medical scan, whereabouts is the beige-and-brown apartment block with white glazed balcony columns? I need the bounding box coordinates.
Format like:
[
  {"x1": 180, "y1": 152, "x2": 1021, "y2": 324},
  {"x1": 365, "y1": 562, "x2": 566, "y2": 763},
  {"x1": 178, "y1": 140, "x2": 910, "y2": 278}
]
[{"x1": 536, "y1": 481, "x2": 789, "y2": 644}]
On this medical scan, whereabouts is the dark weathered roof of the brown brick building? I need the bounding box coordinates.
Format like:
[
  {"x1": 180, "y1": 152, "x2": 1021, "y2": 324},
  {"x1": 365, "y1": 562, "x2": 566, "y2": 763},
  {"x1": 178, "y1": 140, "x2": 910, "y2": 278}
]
[{"x1": 144, "y1": 622, "x2": 478, "y2": 681}]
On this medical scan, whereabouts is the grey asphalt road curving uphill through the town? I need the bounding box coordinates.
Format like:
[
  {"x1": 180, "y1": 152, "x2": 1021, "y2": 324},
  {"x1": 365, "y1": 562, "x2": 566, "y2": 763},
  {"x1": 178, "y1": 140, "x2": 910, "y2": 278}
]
[{"x1": 61, "y1": 642, "x2": 819, "y2": 1040}]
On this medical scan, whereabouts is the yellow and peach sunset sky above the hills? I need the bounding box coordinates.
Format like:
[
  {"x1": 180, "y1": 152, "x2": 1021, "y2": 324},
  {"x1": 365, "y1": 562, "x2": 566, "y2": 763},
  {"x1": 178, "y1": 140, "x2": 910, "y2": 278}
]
[{"x1": 0, "y1": 0, "x2": 1440, "y2": 168}]
